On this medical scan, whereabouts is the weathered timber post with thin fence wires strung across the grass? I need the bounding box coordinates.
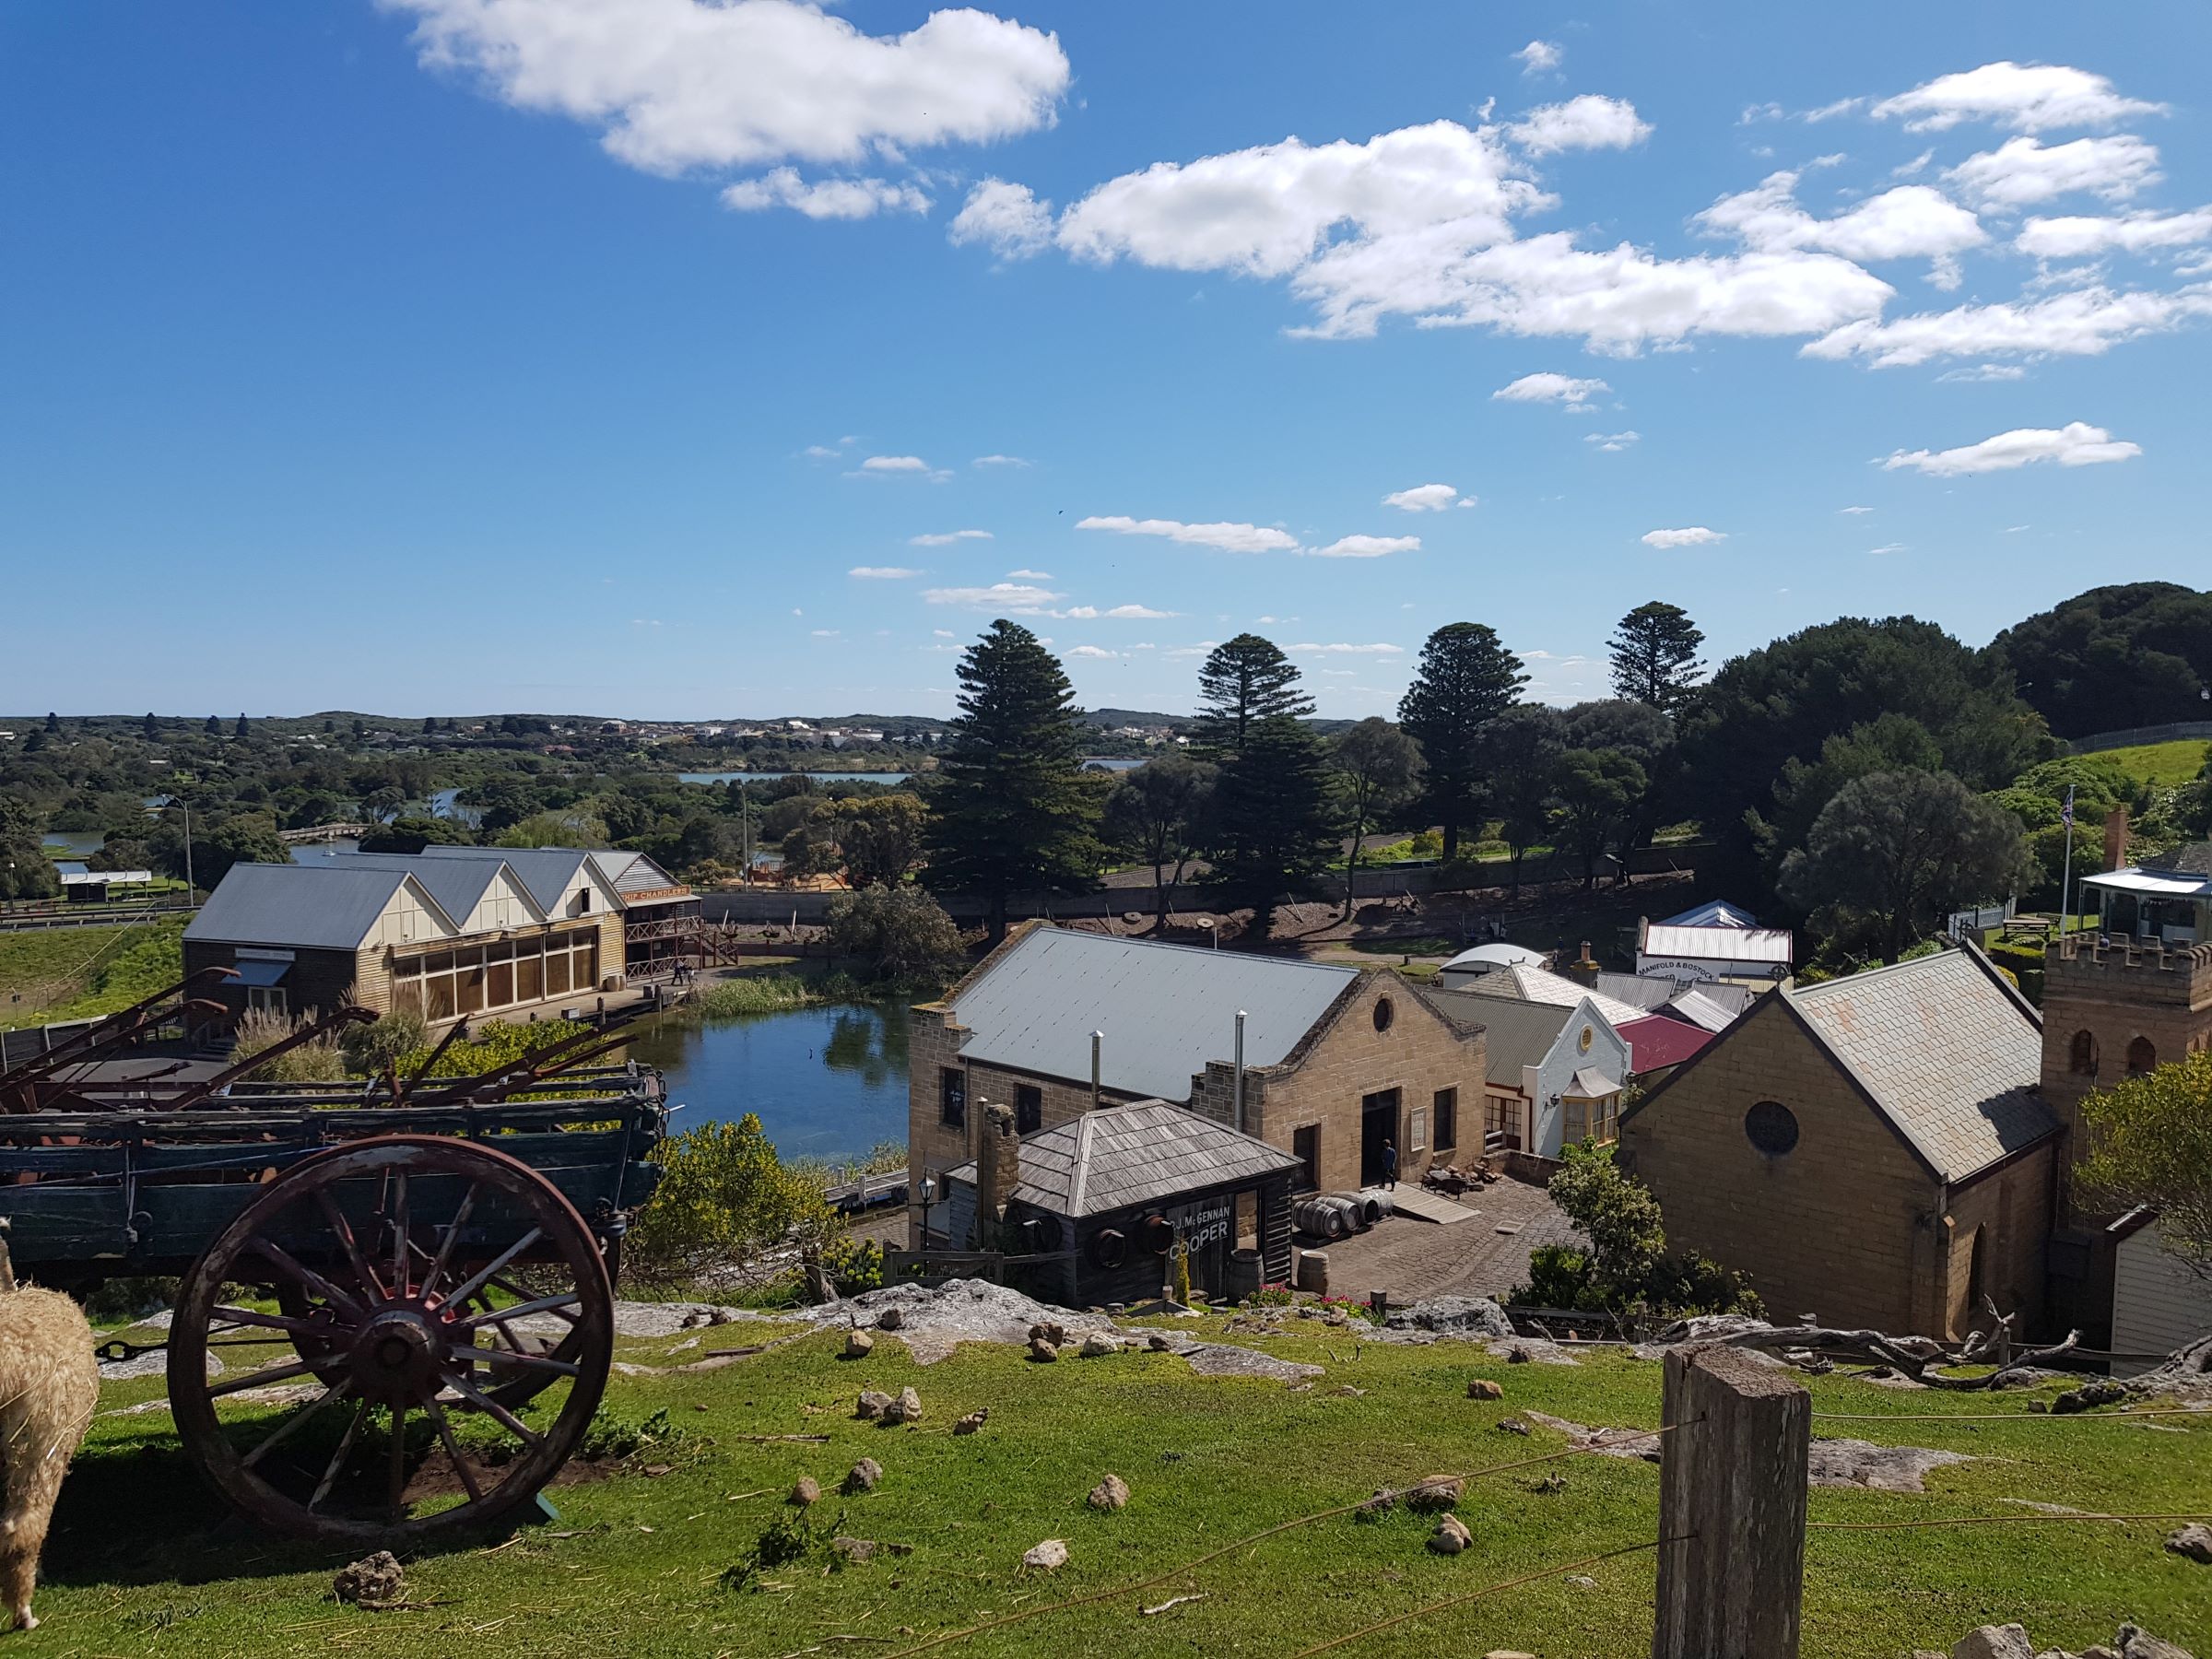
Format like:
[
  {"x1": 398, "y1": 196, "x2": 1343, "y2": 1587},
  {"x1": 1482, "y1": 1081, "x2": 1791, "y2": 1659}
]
[{"x1": 866, "y1": 1343, "x2": 2212, "y2": 1659}]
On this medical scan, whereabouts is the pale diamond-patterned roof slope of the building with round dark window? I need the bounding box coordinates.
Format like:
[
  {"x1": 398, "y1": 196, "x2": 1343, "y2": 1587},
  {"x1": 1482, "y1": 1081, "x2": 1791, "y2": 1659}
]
[{"x1": 1783, "y1": 949, "x2": 2059, "y2": 1182}]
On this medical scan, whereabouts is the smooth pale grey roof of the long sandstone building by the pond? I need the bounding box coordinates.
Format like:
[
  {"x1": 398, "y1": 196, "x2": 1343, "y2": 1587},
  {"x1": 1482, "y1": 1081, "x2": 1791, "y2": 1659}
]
[{"x1": 953, "y1": 927, "x2": 1360, "y2": 1100}]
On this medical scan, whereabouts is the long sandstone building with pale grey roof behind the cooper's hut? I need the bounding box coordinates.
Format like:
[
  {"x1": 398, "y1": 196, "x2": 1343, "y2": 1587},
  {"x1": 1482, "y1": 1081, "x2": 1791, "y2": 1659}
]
[{"x1": 907, "y1": 923, "x2": 1484, "y2": 1245}]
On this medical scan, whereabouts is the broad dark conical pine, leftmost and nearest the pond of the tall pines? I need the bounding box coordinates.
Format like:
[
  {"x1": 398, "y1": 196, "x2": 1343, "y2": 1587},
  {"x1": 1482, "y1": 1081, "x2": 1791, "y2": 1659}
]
[{"x1": 927, "y1": 619, "x2": 1101, "y2": 945}]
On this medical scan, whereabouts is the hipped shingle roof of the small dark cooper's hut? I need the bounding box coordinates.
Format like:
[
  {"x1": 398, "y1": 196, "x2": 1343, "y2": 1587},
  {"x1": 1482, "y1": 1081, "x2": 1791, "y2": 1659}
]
[{"x1": 947, "y1": 1100, "x2": 1299, "y2": 1217}]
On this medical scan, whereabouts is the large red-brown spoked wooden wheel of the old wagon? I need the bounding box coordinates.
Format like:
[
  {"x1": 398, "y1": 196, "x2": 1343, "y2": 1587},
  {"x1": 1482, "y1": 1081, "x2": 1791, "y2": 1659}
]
[{"x1": 168, "y1": 1135, "x2": 615, "y2": 1547}]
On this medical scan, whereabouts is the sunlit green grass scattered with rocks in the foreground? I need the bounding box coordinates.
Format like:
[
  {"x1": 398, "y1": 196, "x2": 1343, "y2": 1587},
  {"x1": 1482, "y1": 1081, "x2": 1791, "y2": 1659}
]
[{"x1": 34, "y1": 1321, "x2": 2212, "y2": 1659}]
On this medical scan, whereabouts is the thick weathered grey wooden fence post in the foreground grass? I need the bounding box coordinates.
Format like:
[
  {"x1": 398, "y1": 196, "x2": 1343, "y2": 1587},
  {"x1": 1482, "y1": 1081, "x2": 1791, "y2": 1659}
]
[{"x1": 1653, "y1": 1345, "x2": 1812, "y2": 1659}]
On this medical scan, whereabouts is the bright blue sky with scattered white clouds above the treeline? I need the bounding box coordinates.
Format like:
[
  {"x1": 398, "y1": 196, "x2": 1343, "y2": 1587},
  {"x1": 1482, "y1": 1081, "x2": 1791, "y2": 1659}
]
[{"x1": 0, "y1": 0, "x2": 2212, "y2": 717}]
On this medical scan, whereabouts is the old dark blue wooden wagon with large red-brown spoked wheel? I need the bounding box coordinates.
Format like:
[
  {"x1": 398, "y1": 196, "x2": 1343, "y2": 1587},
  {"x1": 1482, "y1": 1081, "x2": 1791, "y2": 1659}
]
[{"x1": 0, "y1": 982, "x2": 665, "y2": 1548}]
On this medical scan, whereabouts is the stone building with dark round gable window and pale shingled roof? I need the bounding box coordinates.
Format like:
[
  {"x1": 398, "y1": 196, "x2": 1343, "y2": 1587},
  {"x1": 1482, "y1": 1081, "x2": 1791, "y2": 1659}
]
[{"x1": 1621, "y1": 949, "x2": 2064, "y2": 1338}]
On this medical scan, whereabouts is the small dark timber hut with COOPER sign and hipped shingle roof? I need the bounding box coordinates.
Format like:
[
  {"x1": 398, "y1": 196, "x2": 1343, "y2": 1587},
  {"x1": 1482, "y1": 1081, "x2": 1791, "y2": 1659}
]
[{"x1": 929, "y1": 1100, "x2": 1300, "y2": 1305}]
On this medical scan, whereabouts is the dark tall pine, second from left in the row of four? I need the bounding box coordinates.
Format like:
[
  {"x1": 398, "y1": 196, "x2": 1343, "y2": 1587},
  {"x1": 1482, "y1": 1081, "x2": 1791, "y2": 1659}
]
[{"x1": 1196, "y1": 632, "x2": 1336, "y2": 934}]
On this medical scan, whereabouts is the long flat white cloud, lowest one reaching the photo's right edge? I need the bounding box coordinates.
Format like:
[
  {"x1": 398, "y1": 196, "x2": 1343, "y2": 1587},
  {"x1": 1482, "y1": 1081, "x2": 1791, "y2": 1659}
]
[{"x1": 1803, "y1": 283, "x2": 2212, "y2": 370}]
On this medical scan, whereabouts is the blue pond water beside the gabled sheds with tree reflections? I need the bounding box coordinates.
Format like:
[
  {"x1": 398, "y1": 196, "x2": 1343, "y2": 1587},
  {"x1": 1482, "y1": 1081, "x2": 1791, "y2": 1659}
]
[{"x1": 630, "y1": 1005, "x2": 912, "y2": 1163}]
